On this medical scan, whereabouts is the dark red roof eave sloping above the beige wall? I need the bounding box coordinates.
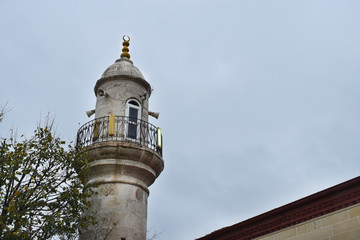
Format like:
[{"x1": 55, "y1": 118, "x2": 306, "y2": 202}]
[{"x1": 197, "y1": 177, "x2": 360, "y2": 240}]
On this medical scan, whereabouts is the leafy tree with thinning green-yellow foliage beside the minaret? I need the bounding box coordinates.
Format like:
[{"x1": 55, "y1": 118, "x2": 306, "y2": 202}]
[{"x1": 0, "y1": 127, "x2": 94, "y2": 239}]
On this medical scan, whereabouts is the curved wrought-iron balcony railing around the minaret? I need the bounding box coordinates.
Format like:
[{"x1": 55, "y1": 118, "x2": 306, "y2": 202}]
[{"x1": 76, "y1": 115, "x2": 162, "y2": 156}]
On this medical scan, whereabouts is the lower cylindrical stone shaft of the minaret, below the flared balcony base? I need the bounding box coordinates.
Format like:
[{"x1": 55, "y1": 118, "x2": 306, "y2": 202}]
[{"x1": 81, "y1": 183, "x2": 148, "y2": 240}]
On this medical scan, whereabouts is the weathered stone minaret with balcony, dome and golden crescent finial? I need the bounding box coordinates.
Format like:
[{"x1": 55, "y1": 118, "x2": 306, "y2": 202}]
[{"x1": 77, "y1": 36, "x2": 164, "y2": 240}]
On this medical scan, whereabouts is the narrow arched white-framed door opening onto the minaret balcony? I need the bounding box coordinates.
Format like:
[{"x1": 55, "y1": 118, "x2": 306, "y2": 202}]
[{"x1": 126, "y1": 99, "x2": 141, "y2": 139}]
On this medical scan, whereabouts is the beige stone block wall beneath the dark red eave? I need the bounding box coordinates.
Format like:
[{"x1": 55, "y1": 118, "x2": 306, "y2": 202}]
[{"x1": 255, "y1": 204, "x2": 360, "y2": 240}]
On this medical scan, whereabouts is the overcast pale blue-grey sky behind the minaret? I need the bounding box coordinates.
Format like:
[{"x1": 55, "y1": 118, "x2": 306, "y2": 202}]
[{"x1": 0, "y1": 0, "x2": 360, "y2": 240}]
